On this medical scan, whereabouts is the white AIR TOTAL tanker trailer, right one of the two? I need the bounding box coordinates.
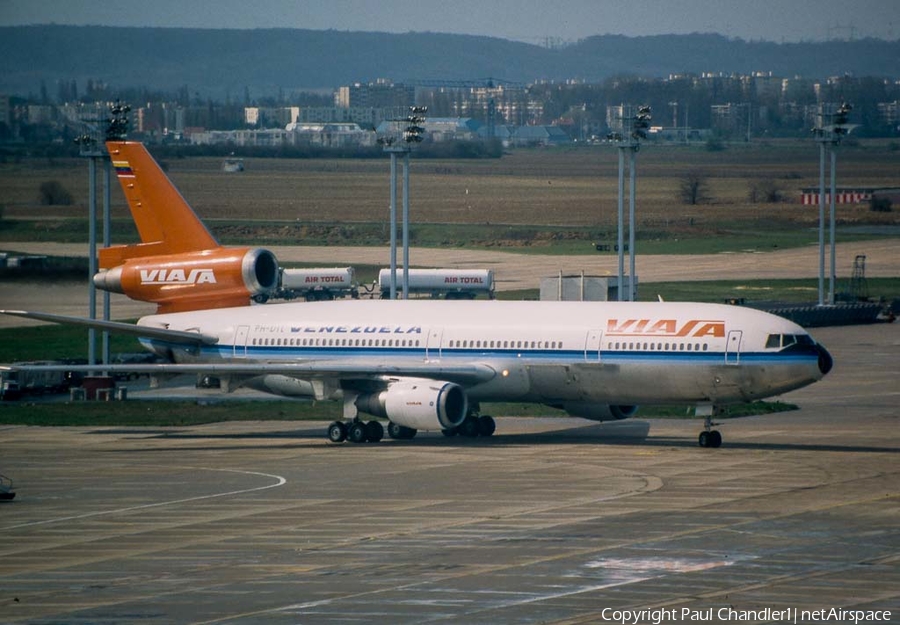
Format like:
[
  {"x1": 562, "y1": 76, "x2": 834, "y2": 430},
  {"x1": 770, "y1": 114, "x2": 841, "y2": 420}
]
[{"x1": 378, "y1": 269, "x2": 494, "y2": 299}]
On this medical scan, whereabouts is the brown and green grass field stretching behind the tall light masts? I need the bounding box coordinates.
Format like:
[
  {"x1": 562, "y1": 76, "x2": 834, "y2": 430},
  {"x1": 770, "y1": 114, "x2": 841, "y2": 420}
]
[{"x1": 0, "y1": 141, "x2": 900, "y2": 253}]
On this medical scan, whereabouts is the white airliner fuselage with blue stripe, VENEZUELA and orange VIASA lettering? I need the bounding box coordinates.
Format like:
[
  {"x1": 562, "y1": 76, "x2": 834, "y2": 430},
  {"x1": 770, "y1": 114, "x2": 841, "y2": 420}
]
[{"x1": 139, "y1": 300, "x2": 831, "y2": 404}]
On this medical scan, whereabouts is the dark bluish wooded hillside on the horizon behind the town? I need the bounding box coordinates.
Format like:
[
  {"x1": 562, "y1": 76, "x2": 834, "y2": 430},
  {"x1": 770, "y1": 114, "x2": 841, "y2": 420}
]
[{"x1": 0, "y1": 26, "x2": 900, "y2": 98}]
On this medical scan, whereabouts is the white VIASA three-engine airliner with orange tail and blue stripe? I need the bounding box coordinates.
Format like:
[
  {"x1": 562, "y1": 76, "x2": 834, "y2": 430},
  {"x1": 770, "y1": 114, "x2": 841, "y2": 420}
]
[{"x1": 2, "y1": 142, "x2": 832, "y2": 447}]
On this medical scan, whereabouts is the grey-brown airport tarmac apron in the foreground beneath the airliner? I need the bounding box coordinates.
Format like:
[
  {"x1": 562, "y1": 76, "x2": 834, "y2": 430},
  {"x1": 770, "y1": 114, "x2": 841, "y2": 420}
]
[{"x1": 0, "y1": 324, "x2": 900, "y2": 625}]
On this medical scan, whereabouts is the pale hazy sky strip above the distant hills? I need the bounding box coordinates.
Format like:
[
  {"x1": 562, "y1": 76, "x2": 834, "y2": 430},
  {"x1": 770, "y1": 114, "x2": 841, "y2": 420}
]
[{"x1": 0, "y1": 0, "x2": 900, "y2": 43}]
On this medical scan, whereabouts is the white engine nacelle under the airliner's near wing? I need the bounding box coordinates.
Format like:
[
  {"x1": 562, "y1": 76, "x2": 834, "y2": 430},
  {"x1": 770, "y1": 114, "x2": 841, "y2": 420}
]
[{"x1": 356, "y1": 378, "x2": 468, "y2": 431}]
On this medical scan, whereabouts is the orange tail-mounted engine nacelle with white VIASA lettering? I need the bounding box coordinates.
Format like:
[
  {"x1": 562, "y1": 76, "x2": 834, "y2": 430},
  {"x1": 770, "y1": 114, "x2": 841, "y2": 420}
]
[{"x1": 94, "y1": 247, "x2": 278, "y2": 313}]
